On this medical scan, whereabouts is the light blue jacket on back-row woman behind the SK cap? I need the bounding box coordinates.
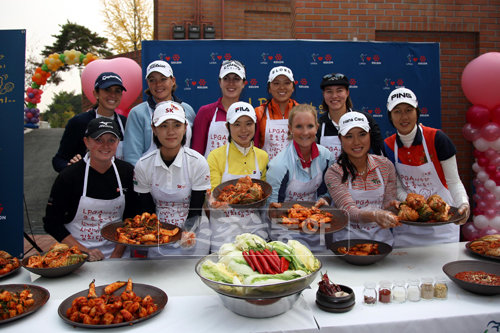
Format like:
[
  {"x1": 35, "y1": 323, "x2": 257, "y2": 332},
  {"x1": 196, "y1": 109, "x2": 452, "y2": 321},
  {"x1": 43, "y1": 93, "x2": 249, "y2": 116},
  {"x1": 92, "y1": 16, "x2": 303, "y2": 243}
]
[{"x1": 123, "y1": 96, "x2": 196, "y2": 165}]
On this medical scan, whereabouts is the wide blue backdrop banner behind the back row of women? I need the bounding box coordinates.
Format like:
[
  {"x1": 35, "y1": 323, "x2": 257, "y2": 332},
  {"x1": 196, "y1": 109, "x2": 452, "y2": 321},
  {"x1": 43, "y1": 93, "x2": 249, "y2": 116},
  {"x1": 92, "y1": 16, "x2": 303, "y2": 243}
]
[{"x1": 142, "y1": 40, "x2": 441, "y2": 136}]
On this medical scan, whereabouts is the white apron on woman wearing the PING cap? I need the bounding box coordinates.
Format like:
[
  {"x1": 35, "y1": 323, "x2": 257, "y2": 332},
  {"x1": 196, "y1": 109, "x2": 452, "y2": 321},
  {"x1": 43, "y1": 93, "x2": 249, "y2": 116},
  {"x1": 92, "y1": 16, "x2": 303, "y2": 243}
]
[{"x1": 394, "y1": 125, "x2": 460, "y2": 247}]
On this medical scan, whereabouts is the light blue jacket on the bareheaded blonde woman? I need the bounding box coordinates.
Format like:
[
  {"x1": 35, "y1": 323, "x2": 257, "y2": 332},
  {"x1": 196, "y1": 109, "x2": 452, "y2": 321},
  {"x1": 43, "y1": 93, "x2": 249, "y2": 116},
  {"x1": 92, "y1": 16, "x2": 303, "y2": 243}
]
[{"x1": 266, "y1": 143, "x2": 333, "y2": 204}]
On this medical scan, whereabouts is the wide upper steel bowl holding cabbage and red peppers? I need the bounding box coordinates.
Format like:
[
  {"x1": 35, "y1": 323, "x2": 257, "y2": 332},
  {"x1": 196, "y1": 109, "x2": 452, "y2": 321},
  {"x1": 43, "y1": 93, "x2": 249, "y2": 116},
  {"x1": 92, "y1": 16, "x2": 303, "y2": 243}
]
[{"x1": 195, "y1": 253, "x2": 322, "y2": 300}]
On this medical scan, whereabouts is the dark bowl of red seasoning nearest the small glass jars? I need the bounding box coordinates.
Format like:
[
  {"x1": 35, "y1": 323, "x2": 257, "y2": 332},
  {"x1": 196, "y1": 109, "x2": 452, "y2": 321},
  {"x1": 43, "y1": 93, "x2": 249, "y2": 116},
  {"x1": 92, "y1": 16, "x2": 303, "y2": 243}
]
[{"x1": 443, "y1": 260, "x2": 500, "y2": 295}]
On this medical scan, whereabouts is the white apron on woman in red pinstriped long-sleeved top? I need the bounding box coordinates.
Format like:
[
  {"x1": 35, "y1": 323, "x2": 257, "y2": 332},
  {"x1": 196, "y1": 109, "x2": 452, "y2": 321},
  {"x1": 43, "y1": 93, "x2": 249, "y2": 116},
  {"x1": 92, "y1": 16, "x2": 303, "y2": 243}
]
[{"x1": 331, "y1": 168, "x2": 399, "y2": 245}]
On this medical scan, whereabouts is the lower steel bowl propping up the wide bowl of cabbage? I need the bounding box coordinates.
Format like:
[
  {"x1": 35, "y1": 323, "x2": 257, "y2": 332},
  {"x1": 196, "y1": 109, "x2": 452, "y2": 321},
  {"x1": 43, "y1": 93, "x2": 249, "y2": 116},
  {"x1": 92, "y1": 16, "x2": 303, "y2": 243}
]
[{"x1": 219, "y1": 292, "x2": 301, "y2": 318}]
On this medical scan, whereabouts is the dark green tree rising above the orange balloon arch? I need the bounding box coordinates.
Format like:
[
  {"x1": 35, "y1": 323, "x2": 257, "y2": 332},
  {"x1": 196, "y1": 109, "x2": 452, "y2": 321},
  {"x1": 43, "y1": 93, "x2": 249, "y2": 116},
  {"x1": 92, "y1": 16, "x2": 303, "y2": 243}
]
[{"x1": 40, "y1": 21, "x2": 112, "y2": 85}]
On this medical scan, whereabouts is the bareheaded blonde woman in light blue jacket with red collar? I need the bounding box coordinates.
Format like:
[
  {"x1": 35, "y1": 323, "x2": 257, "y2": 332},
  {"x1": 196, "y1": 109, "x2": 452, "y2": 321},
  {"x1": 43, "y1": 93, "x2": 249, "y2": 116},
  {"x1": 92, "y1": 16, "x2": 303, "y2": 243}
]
[{"x1": 266, "y1": 104, "x2": 332, "y2": 252}]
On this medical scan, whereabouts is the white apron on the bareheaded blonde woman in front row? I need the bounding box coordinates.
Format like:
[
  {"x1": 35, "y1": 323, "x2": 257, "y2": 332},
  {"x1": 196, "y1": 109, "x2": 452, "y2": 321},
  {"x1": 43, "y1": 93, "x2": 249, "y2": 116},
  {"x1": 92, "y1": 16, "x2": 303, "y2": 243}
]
[{"x1": 270, "y1": 148, "x2": 327, "y2": 253}]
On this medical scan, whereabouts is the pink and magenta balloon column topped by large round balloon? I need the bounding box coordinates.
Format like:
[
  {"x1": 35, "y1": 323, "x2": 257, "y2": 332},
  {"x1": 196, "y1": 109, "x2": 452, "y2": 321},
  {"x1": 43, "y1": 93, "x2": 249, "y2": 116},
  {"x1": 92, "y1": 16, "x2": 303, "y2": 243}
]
[{"x1": 462, "y1": 52, "x2": 500, "y2": 240}]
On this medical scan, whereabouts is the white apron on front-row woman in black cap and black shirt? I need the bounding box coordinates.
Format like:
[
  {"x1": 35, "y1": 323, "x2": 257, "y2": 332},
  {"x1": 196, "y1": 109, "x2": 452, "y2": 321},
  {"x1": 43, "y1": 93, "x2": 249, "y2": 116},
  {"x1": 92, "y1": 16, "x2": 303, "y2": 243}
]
[{"x1": 66, "y1": 154, "x2": 125, "y2": 258}]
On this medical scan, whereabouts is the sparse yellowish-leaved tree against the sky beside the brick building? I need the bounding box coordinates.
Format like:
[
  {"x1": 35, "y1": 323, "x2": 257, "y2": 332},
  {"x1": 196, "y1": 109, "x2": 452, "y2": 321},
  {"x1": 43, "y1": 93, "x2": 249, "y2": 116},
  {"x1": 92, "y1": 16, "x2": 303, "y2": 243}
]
[{"x1": 102, "y1": 0, "x2": 153, "y2": 53}]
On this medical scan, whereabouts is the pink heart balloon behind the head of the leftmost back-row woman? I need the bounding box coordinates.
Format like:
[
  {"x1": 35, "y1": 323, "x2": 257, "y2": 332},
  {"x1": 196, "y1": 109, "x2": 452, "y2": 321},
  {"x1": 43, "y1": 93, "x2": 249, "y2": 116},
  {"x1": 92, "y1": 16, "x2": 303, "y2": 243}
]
[{"x1": 81, "y1": 57, "x2": 142, "y2": 116}]
